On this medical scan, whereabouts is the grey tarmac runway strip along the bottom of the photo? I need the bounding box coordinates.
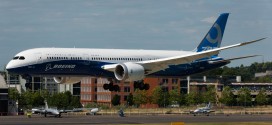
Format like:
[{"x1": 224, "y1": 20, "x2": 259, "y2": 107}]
[{"x1": 0, "y1": 115, "x2": 272, "y2": 125}]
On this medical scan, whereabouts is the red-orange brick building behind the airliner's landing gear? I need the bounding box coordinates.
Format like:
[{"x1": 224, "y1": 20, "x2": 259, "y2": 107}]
[{"x1": 81, "y1": 77, "x2": 182, "y2": 106}]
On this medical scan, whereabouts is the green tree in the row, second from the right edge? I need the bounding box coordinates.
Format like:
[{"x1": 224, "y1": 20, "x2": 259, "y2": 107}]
[{"x1": 237, "y1": 87, "x2": 252, "y2": 106}]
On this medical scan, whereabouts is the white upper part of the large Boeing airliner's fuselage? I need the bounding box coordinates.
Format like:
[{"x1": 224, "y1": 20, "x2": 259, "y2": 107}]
[{"x1": 7, "y1": 48, "x2": 194, "y2": 69}]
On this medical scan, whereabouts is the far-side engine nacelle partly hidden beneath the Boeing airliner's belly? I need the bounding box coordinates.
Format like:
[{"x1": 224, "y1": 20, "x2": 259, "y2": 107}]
[{"x1": 54, "y1": 77, "x2": 81, "y2": 84}]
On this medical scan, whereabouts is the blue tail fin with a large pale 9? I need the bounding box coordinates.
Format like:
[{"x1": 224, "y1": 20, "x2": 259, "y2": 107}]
[{"x1": 196, "y1": 13, "x2": 229, "y2": 52}]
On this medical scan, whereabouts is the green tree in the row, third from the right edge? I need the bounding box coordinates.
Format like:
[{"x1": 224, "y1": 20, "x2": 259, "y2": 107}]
[{"x1": 220, "y1": 86, "x2": 235, "y2": 106}]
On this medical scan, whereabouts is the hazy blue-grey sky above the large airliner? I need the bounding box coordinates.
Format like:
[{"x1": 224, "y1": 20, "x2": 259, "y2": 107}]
[{"x1": 0, "y1": 0, "x2": 272, "y2": 70}]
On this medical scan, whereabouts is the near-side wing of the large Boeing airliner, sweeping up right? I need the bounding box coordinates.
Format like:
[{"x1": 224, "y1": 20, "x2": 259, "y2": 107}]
[{"x1": 102, "y1": 38, "x2": 265, "y2": 75}]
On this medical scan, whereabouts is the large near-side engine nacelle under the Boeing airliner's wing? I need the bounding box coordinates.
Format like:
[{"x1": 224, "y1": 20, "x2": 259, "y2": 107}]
[{"x1": 114, "y1": 62, "x2": 145, "y2": 81}]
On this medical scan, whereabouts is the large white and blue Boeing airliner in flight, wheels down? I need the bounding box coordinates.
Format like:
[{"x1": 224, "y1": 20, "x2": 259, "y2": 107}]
[{"x1": 6, "y1": 13, "x2": 265, "y2": 91}]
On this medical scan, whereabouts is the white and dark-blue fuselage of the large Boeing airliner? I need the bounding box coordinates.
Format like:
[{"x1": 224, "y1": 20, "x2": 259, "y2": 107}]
[{"x1": 6, "y1": 48, "x2": 226, "y2": 78}]
